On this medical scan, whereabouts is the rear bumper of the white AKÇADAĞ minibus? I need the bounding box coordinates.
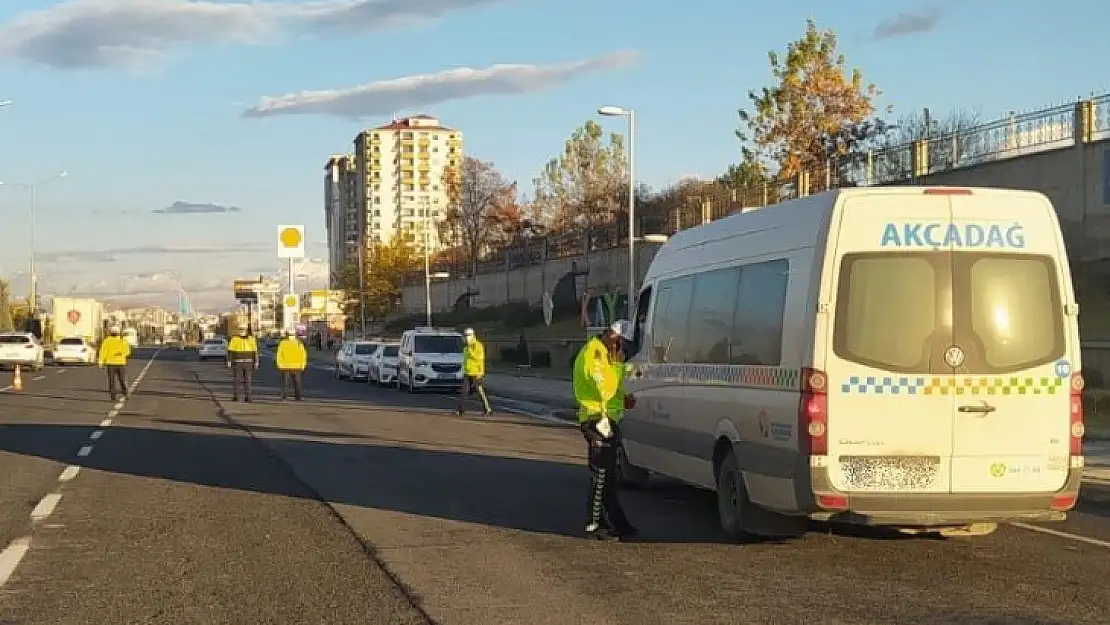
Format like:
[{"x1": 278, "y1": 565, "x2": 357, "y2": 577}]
[{"x1": 808, "y1": 467, "x2": 1083, "y2": 527}]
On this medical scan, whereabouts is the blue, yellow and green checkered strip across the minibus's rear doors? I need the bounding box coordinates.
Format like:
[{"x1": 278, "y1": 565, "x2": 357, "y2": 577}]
[{"x1": 840, "y1": 375, "x2": 1063, "y2": 395}]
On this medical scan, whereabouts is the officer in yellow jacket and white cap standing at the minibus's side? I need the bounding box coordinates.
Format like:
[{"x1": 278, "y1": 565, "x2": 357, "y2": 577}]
[{"x1": 573, "y1": 321, "x2": 636, "y2": 541}]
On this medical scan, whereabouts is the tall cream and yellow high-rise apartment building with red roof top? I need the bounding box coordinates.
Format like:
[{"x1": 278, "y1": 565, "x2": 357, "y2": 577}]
[{"x1": 324, "y1": 115, "x2": 463, "y2": 286}]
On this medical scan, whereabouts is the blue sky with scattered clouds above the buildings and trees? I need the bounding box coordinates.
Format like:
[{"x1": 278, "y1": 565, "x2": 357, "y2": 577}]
[{"x1": 0, "y1": 0, "x2": 1110, "y2": 308}]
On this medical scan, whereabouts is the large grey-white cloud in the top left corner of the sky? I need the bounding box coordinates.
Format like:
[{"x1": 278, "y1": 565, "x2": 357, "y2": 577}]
[{"x1": 0, "y1": 0, "x2": 502, "y2": 70}]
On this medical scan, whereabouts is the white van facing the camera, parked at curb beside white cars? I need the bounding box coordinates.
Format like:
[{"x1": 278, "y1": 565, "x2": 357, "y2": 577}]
[{"x1": 397, "y1": 327, "x2": 464, "y2": 393}]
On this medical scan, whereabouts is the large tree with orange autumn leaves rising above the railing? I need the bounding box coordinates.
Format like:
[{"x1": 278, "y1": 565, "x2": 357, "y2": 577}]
[{"x1": 736, "y1": 20, "x2": 888, "y2": 179}]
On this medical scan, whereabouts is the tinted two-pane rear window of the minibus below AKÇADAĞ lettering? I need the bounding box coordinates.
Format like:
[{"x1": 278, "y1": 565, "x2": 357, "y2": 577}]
[{"x1": 833, "y1": 252, "x2": 1067, "y2": 374}]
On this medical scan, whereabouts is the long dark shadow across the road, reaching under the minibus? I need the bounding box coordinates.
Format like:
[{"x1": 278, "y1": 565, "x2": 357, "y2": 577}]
[{"x1": 0, "y1": 422, "x2": 759, "y2": 543}]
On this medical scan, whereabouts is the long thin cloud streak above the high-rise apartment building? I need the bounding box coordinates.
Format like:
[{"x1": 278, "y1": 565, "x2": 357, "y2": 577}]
[{"x1": 243, "y1": 51, "x2": 638, "y2": 119}]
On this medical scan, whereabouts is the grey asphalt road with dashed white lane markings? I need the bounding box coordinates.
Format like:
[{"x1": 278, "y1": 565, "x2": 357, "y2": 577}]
[{"x1": 0, "y1": 351, "x2": 1110, "y2": 625}]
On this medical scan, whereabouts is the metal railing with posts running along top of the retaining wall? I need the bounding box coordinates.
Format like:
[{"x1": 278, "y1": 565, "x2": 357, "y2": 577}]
[{"x1": 405, "y1": 94, "x2": 1110, "y2": 284}]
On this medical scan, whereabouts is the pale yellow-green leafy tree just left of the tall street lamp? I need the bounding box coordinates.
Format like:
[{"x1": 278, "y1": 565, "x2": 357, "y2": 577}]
[{"x1": 533, "y1": 121, "x2": 628, "y2": 230}]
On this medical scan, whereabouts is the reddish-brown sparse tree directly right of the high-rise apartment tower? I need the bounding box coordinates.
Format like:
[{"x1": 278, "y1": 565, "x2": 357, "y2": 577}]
[{"x1": 444, "y1": 157, "x2": 516, "y2": 274}]
